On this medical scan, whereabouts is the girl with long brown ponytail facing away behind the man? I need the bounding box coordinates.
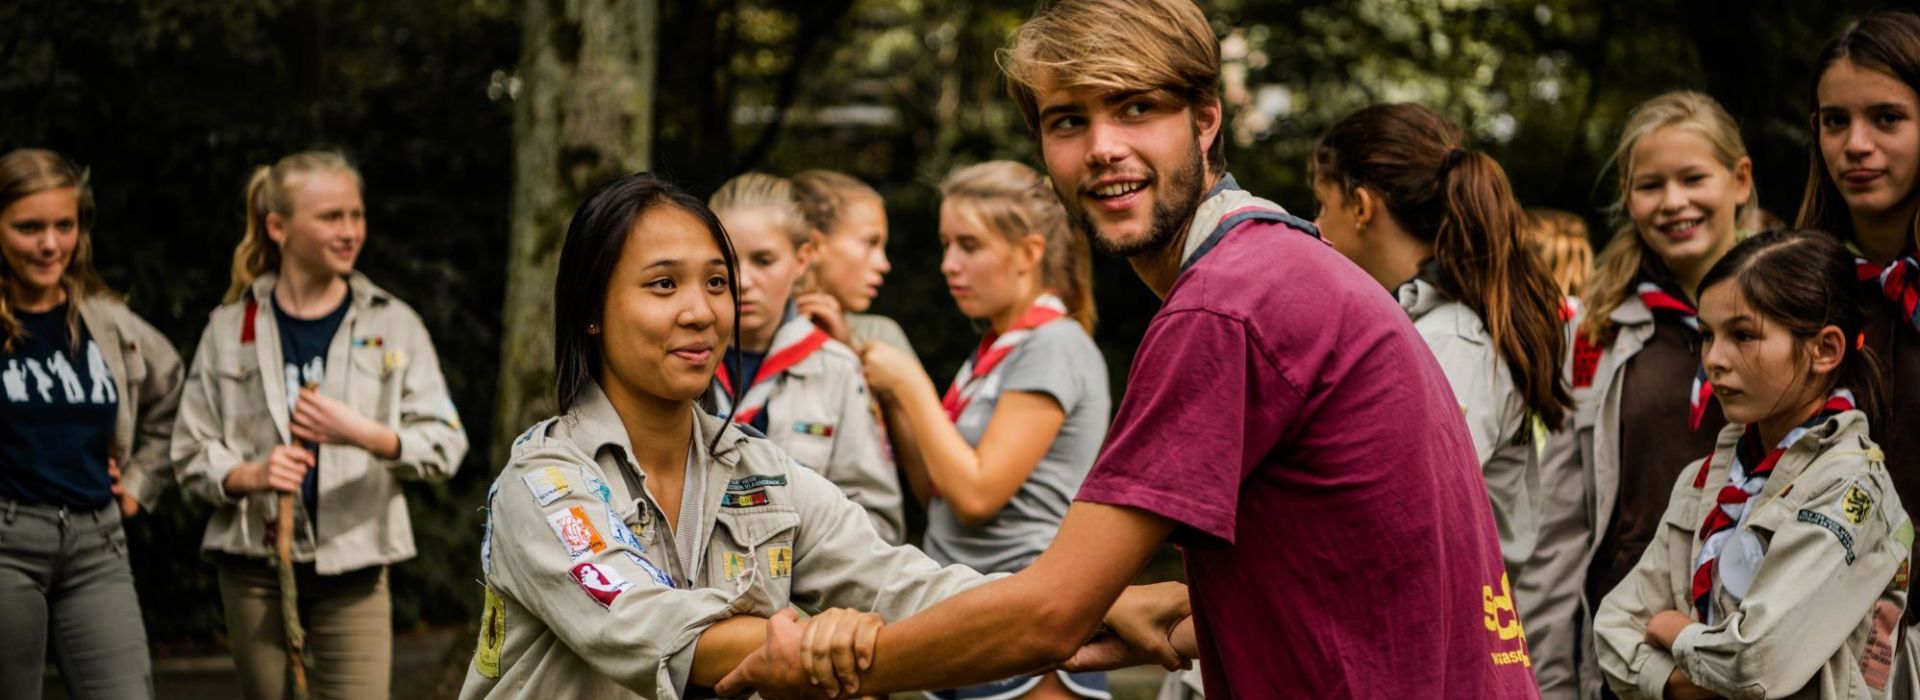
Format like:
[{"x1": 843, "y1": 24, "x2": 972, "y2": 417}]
[{"x1": 1311, "y1": 104, "x2": 1572, "y2": 579}]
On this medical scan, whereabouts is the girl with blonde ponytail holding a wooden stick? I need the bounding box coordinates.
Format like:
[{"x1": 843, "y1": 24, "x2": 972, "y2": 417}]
[{"x1": 173, "y1": 152, "x2": 467, "y2": 698}]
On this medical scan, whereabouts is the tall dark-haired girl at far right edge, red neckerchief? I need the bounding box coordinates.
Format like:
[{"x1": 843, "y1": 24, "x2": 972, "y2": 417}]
[{"x1": 1799, "y1": 12, "x2": 1920, "y2": 698}]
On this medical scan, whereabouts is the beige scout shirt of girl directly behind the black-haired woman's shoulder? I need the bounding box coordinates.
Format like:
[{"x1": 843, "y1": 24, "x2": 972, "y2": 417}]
[{"x1": 748, "y1": 339, "x2": 906, "y2": 545}]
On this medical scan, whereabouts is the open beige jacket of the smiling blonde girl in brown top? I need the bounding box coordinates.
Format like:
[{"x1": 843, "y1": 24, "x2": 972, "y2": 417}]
[{"x1": 1515, "y1": 295, "x2": 1658, "y2": 700}]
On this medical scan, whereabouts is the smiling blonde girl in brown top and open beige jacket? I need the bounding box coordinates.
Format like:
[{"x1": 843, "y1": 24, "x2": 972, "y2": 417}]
[{"x1": 1521, "y1": 90, "x2": 1757, "y2": 698}]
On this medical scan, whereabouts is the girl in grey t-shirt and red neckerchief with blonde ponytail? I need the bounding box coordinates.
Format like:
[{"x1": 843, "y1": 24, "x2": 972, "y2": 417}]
[{"x1": 862, "y1": 161, "x2": 1110, "y2": 698}]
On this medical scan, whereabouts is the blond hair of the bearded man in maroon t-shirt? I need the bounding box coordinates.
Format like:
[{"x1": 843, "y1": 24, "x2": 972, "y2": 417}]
[{"x1": 998, "y1": 0, "x2": 1227, "y2": 173}]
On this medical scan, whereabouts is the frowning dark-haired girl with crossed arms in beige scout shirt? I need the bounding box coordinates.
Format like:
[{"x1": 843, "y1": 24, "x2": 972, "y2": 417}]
[{"x1": 1594, "y1": 230, "x2": 1912, "y2": 700}]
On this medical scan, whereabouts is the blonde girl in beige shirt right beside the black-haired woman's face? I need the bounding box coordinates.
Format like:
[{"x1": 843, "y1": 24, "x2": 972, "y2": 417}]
[{"x1": 708, "y1": 173, "x2": 906, "y2": 545}]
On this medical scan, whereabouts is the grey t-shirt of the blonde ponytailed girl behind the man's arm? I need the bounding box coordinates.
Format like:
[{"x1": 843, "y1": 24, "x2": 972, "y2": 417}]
[{"x1": 925, "y1": 318, "x2": 1112, "y2": 572}]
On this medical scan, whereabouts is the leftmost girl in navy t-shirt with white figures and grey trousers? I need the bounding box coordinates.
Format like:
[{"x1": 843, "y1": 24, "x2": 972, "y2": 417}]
[{"x1": 0, "y1": 148, "x2": 180, "y2": 698}]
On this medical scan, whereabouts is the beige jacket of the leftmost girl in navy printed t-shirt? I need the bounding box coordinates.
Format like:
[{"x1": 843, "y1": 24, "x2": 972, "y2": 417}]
[{"x1": 81, "y1": 295, "x2": 180, "y2": 510}]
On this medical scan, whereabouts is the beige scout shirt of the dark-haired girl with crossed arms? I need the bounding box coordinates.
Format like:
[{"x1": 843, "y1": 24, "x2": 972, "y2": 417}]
[{"x1": 1594, "y1": 410, "x2": 1912, "y2": 698}]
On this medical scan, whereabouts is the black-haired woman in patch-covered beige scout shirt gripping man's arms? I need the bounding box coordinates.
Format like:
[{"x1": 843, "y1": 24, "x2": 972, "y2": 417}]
[{"x1": 461, "y1": 173, "x2": 985, "y2": 698}]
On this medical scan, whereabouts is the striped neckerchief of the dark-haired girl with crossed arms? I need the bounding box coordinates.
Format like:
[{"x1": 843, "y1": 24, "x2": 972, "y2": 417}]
[{"x1": 1692, "y1": 389, "x2": 1853, "y2": 625}]
